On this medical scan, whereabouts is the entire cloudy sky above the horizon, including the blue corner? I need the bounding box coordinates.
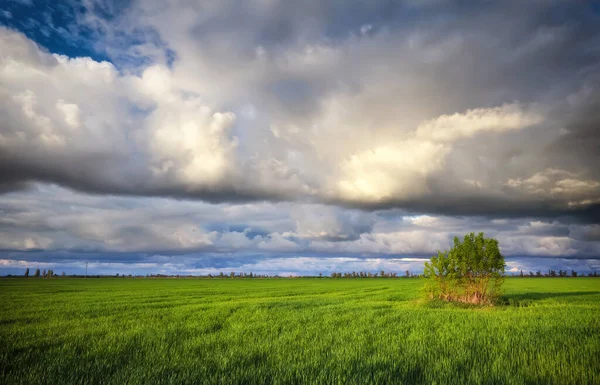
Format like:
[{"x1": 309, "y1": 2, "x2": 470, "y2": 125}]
[{"x1": 0, "y1": 0, "x2": 600, "y2": 275}]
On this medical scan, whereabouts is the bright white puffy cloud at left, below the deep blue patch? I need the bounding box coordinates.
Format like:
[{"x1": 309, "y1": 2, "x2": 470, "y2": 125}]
[{"x1": 0, "y1": 30, "x2": 251, "y2": 200}]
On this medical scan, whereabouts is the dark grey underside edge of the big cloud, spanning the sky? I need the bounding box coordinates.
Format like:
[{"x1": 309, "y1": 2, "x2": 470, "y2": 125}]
[{"x1": 0, "y1": 164, "x2": 600, "y2": 223}]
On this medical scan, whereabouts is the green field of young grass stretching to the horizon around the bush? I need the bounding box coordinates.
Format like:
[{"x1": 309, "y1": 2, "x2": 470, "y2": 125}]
[{"x1": 0, "y1": 278, "x2": 600, "y2": 385}]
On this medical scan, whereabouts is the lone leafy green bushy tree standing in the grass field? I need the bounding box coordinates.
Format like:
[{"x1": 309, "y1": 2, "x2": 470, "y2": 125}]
[{"x1": 424, "y1": 233, "x2": 505, "y2": 304}]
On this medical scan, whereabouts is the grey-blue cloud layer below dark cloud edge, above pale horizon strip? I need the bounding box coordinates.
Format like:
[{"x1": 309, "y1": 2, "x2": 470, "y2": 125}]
[{"x1": 0, "y1": 185, "x2": 600, "y2": 260}]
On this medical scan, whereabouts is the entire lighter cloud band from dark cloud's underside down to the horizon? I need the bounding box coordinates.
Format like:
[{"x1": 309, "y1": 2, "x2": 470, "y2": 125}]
[{"x1": 0, "y1": 184, "x2": 600, "y2": 275}]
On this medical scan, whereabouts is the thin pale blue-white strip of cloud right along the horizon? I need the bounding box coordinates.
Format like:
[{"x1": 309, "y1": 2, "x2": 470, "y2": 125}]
[{"x1": 0, "y1": 256, "x2": 600, "y2": 277}]
